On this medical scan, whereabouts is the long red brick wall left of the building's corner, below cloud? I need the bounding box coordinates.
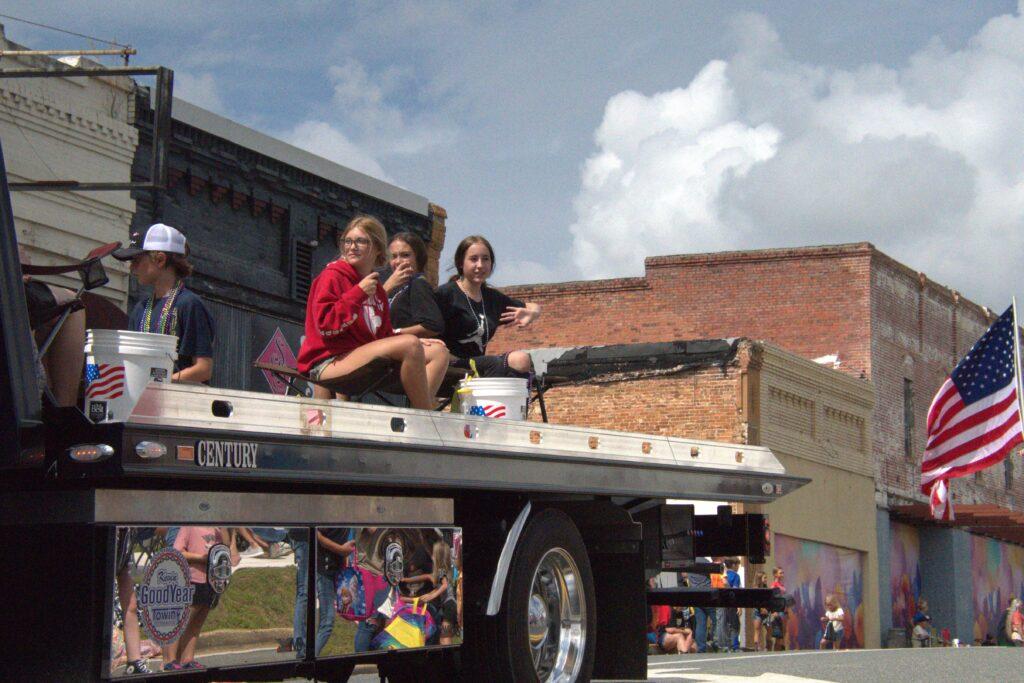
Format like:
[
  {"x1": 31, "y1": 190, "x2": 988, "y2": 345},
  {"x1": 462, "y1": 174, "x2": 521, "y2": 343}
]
[{"x1": 494, "y1": 244, "x2": 871, "y2": 376}]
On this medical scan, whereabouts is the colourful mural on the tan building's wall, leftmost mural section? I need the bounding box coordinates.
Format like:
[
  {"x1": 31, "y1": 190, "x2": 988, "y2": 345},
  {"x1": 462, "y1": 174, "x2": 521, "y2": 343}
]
[{"x1": 773, "y1": 533, "x2": 864, "y2": 650}]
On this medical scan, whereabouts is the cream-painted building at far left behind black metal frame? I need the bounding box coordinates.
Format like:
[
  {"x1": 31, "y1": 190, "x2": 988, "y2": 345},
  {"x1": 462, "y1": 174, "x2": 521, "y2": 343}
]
[{"x1": 0, "y1": 27, "x2": 138, "y2": 305}]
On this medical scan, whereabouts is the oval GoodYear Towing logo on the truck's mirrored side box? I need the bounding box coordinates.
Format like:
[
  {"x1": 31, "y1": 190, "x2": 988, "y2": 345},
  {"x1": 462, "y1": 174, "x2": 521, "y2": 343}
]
[{"x1": 135, "y1": 548, "x2": 196, "y2": 645}]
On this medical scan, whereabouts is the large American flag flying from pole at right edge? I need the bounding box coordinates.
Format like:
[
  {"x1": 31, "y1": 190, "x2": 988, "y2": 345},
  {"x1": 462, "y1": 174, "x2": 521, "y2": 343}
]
[{"x1": 921, "y1": 306, "x2": 1024, "y2": 519}]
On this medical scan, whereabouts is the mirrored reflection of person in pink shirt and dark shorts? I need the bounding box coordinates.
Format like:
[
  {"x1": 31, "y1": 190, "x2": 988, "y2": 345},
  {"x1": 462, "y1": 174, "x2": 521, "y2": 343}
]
[{"x1": 164, "y1": 526, "x2": 242, "y2": 671}]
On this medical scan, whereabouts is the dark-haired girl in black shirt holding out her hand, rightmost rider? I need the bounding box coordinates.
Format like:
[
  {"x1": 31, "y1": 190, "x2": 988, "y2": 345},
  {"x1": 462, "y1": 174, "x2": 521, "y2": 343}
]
[{"x1": 436, "y1": 234, "x2": 541, "y2": 377}]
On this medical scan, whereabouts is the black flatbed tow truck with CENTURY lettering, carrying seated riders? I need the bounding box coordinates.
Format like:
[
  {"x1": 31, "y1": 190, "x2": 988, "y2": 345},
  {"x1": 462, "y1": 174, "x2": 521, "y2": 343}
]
[{"x1": 0, "y1": 140, "x2": 806, "y2": 681}]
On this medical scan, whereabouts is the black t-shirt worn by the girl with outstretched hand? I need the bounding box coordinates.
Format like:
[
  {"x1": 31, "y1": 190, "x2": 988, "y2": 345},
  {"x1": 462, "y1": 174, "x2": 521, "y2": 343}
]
[{"x1": 436, "y1": 281, "x2": 525, "y2": 358}]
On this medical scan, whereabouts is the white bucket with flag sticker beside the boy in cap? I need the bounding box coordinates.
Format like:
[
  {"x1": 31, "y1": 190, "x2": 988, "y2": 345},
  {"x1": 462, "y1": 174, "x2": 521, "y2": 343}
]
[{"x1": 85, "y1": 330, "x2": 178, "y2": 422}]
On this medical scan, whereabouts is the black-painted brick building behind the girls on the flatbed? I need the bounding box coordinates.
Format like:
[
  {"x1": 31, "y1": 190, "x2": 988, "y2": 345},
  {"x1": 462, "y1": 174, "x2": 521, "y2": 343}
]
[{"x1": 129, "y1": 97, "x2": 432, "y2": 390}]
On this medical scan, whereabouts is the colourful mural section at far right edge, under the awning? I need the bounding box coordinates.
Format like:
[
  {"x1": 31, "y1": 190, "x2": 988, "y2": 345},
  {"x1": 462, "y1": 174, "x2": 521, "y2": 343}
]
[{"x1": 971, "y1": 536, "x2": 1024, "y2": 640}]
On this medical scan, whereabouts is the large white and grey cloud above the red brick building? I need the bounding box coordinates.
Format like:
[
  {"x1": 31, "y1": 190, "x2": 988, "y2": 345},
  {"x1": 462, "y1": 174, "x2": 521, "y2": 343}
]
[{"x1": 571, "y1": 3, "x2": 1024, "y2": 306}]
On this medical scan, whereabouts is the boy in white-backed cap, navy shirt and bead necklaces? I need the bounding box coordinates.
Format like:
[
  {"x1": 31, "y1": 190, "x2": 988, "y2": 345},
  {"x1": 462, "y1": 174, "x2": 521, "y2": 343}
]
[{"x1": 114, "y1": 223, "x2": 214, "y2": 382}]
